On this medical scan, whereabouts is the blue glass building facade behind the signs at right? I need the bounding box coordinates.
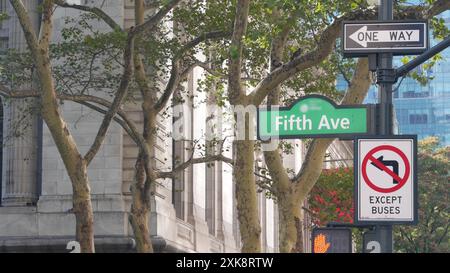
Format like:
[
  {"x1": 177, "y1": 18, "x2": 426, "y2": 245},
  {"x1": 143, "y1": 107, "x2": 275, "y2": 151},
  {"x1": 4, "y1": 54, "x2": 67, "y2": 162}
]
[{"x1": 338, "y1": 12, "x2": 450, "y2": 145}]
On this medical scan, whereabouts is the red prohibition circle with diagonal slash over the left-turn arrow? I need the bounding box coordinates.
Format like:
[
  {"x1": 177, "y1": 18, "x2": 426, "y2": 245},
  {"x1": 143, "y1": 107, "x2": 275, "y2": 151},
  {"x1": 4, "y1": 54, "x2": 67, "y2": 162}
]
[{"x1": 361, "y1": 145, "x2": 411, "y2": 193}]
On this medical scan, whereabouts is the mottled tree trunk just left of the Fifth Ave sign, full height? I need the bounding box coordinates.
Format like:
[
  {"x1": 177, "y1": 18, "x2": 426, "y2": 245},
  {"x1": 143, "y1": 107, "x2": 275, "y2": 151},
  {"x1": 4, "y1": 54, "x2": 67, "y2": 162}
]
[{"x1": 228, "y1": 0, "x2": 261, "y2": 252}]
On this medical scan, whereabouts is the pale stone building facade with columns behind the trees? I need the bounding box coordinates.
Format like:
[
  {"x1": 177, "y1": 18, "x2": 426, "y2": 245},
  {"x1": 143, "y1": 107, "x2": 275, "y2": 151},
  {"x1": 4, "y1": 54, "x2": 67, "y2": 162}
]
[{"x1": 0, "y1": 0, "x2": 351, "y2": 252}]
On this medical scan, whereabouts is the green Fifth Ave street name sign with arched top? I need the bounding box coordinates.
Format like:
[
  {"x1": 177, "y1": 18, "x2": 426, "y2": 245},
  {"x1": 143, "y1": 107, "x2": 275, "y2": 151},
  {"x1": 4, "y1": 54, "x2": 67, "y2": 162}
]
[{"x1": 258, "y1": 95, "x2": 369, "y2": 140}]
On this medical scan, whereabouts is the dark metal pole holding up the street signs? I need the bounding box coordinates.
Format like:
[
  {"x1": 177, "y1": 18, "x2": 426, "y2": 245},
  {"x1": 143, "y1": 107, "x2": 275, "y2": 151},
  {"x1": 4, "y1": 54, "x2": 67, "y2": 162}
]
[{"x1": 375, "y1": 0, "x2": 394, "y2": 253}]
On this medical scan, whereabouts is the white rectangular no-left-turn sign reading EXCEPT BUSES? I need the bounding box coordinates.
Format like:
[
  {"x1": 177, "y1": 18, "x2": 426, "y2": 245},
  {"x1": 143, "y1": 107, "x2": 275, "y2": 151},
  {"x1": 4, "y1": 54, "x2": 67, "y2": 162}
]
[{"x1": 355, "y1": 136, "x2": 417, "y2": 223}]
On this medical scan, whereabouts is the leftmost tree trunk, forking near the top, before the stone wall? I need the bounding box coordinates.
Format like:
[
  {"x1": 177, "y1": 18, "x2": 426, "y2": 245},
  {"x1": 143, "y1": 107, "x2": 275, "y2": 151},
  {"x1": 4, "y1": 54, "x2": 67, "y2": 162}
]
[{"x1": 10, "y1": 0, "x2": 95, "y2": 252}]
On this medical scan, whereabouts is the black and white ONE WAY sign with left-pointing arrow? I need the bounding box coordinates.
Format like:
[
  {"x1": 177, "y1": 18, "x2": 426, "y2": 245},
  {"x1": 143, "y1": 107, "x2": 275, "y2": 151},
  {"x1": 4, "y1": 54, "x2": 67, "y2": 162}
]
[{"x1": 342, "y1": 21, "x2": 428, "y2": 57}]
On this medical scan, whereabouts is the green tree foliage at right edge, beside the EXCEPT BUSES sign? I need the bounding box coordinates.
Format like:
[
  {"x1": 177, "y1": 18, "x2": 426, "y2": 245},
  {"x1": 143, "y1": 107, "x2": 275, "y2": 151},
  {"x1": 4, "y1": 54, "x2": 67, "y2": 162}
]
[{"x1": 394, "y1": 137, "x2": 450, "y2": 253}]
